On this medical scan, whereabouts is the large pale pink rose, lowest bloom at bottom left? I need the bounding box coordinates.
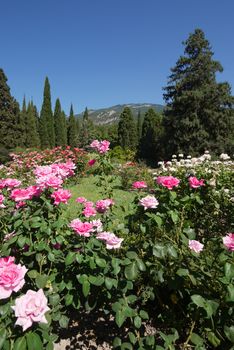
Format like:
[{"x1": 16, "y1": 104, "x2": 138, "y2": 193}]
[{"x1": 12, "y1": 289, "x2": 50, "y2": 331}]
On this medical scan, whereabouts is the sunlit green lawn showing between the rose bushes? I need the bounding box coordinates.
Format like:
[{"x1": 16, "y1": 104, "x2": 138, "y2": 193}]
[{"x1": 65, "y1": 176, "x2": 135, "y2": 219}]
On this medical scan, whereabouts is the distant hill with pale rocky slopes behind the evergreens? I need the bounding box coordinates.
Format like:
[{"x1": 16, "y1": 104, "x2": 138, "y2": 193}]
[{"x1": 76, "y1": 103, "x2": 164, "y2": 125}]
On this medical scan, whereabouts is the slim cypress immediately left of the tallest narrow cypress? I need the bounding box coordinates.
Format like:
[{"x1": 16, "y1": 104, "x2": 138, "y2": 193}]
[{"x1": 25, "y1": 101, "x2": 40, "y2": 148}]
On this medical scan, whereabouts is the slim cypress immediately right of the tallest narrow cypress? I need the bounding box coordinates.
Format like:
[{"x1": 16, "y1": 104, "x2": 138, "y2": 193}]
[{"x1": 54, "y1": 98, "x2": 67, "y2": 146}]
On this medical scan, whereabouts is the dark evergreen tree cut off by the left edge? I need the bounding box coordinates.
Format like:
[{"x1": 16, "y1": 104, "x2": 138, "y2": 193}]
[{"x1": 0, "y1": 69, "x2": 21, "y2": 148}]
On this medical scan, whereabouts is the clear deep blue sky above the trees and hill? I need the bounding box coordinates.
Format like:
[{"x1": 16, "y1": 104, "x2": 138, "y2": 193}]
[{"x1": 0, "y1": 0, "x2": 234, "y2": 113}]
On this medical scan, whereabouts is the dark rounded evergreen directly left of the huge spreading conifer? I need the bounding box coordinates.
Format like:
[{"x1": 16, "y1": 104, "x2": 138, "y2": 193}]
[{"x1": 139, "y1": 108, "x2": 162, "y2": 161}]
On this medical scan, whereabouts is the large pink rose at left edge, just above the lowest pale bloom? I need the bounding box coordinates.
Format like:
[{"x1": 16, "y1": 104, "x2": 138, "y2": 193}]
[{"x1": 0, "y1": 257, "x2": 28, "y2": 299}]
